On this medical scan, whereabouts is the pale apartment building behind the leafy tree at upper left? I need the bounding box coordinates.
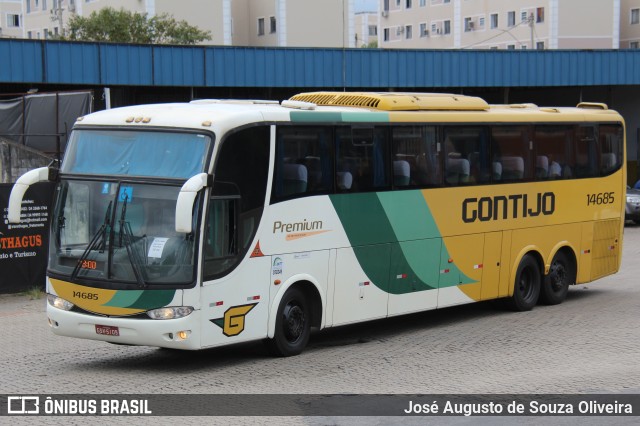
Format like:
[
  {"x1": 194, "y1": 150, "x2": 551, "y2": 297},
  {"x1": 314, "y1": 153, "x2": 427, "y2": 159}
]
[{"x1": 0, "y1": 0, "x2": 362, "y2": 47}]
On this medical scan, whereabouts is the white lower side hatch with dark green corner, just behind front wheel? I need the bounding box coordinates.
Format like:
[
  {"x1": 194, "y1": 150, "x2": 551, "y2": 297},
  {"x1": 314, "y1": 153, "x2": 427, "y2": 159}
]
[{"x1": 333, "y1": 244, "x2": 391, "y2": 326}]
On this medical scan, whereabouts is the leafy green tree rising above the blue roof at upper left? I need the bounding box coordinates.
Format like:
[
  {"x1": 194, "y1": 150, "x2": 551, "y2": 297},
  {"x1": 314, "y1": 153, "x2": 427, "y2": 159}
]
[{"x1": 61, "y1": 7, "x2": 211, "y2": 44}]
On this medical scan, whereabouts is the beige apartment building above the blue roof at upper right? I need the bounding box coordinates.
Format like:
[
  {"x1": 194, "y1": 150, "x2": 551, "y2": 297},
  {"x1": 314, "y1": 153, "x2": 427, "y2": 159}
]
[{"x1": 378, "y1": 0, "x2": 624, "y2": 49}]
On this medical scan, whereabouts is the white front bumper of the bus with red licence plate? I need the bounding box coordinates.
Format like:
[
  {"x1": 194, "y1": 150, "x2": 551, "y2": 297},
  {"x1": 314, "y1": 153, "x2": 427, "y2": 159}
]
[{"x1": 47, "y1": 304, "x2": 201, "y2": 350}]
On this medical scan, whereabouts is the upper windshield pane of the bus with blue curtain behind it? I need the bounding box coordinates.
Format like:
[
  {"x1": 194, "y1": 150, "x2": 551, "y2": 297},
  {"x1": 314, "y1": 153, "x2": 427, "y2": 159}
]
[{"x1": 60, "y1": 129, "x2": 211, "y2": 179}]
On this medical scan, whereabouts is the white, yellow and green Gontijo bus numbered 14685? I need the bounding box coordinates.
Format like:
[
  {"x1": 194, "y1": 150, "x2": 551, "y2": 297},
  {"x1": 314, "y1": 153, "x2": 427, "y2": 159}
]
[{"x1": 9, "y1": 92, "x2": 626, "y2": 356}]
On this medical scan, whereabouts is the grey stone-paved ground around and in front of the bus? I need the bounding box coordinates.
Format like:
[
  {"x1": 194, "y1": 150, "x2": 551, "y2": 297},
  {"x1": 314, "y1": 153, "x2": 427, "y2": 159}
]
[{"x1": 0, "y1": 225, "x2": 640, "y2": 425}]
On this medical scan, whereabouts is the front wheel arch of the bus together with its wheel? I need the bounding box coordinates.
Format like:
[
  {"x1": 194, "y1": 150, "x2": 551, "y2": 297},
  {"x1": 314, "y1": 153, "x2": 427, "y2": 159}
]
[{"x1": 265, "y1": 280, "x2": 323, "y2": 356}]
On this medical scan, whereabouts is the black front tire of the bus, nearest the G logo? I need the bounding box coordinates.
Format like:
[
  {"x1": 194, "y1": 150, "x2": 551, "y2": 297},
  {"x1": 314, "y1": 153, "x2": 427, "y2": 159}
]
[{"x1": 266, "y1": 287, "x2": 311, "y2": 357}]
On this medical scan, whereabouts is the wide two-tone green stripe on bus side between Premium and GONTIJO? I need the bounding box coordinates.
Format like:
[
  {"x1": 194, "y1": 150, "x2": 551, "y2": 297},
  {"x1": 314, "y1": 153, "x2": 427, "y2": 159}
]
[{"x1": 329, "y1": 191, "x2": 475, "y2": 294}]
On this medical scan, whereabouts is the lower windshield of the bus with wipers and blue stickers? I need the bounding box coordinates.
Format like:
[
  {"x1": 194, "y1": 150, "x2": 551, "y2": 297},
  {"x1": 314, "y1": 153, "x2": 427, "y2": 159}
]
[{"x1": 49, "y1": 180, "x2": 197, "y2": 287}]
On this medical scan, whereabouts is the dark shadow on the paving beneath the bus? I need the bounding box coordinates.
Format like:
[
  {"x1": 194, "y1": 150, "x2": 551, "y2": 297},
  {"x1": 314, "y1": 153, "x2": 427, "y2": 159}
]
[{"x1": 74, "y1": 285, "x2": 604, "y2": 373}]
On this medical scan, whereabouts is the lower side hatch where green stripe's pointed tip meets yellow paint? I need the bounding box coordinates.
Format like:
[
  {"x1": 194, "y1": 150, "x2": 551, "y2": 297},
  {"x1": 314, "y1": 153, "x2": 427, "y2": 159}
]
[{"x1": 438, "y1": 234, "x2": 485, "y2": 308}]
